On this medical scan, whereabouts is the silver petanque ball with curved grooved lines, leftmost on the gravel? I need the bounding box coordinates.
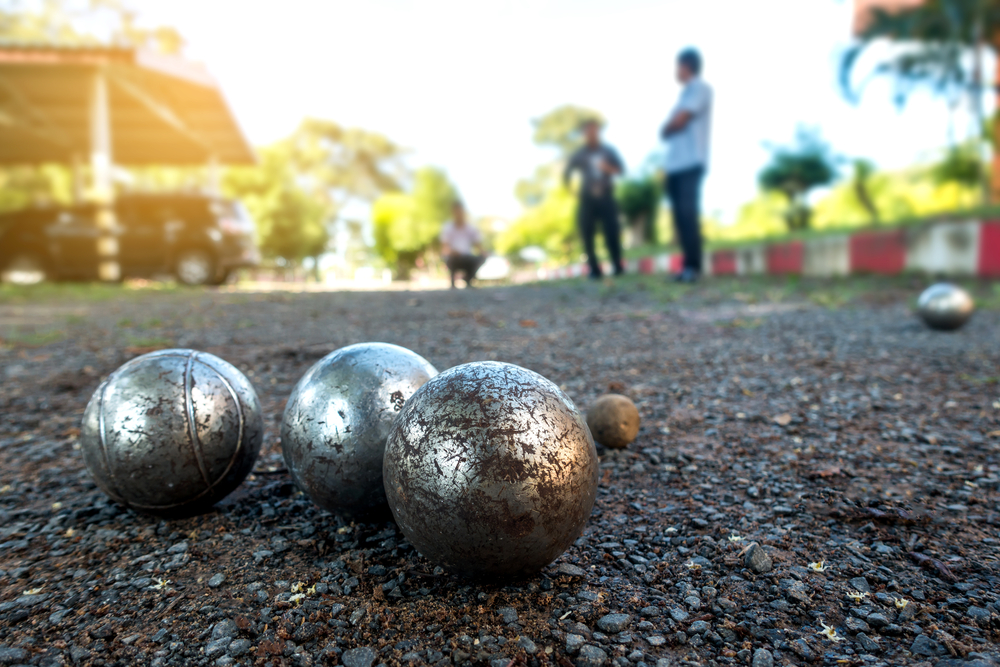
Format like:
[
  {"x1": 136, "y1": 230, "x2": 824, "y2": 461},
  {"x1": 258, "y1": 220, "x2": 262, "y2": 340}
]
[{"x1": 80, "y1": 350, "x2": 264, "y2": 516}]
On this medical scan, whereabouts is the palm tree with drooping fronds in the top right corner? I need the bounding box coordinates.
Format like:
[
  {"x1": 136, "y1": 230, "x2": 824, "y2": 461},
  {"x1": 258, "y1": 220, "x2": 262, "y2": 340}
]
[{"x1": 840, "y1": 0, "x2": 1000, "y2": 199}]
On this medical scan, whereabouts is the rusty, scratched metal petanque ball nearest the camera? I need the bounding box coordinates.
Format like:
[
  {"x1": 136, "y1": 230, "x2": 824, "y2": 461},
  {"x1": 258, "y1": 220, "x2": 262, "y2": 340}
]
[{"x1": 383, "y1": 361, "x2": 598, "y2": 577}]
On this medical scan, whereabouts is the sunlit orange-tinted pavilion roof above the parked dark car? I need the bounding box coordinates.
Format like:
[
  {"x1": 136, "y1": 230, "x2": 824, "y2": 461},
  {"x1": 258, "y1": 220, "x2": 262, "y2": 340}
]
[{"x1": 0, "y1": 42, "x2": 255, "y2": 166}]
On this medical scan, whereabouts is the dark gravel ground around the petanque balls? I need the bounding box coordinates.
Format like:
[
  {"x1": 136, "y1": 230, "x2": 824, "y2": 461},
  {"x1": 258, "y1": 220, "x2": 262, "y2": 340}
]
[{"x1": 0, "y1": 278, "x2": 1000, "y2": 667}]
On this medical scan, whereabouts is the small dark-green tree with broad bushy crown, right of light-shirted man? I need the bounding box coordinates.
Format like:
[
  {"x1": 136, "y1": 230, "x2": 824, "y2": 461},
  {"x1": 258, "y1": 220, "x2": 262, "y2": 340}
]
[{"x1": 758, "y1": 129, "x2": 837, "y2": 230}]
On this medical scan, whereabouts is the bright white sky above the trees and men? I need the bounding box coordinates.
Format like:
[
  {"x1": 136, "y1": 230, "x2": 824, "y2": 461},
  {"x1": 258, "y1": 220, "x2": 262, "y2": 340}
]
[{"x1": 137, "y1": 0, "x2": 980, "y2": 224}]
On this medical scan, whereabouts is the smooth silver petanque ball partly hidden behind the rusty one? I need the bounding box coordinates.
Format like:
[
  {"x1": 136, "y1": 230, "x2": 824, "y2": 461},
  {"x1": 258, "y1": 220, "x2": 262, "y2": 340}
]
[{"x1": 281, "y1": 343, "x2": 437, "y2": 516}]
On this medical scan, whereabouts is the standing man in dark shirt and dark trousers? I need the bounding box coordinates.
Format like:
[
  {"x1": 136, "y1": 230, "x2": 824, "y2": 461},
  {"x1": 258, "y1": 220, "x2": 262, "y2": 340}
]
[{"x1": 563, "y1": 120, "x2": 625, "y2": 280}]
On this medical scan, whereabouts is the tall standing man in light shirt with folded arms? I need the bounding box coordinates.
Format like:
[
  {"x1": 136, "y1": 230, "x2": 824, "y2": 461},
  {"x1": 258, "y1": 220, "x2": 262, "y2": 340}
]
[{"x1": 660, "y1": 49, "x2": 712, "y2": 283}]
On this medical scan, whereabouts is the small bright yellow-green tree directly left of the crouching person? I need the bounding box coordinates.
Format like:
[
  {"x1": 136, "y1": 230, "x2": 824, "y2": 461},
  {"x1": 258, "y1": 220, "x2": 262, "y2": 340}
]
[{"x1": 372, "y1": 167, "x2": 458, "y2": 278}]
